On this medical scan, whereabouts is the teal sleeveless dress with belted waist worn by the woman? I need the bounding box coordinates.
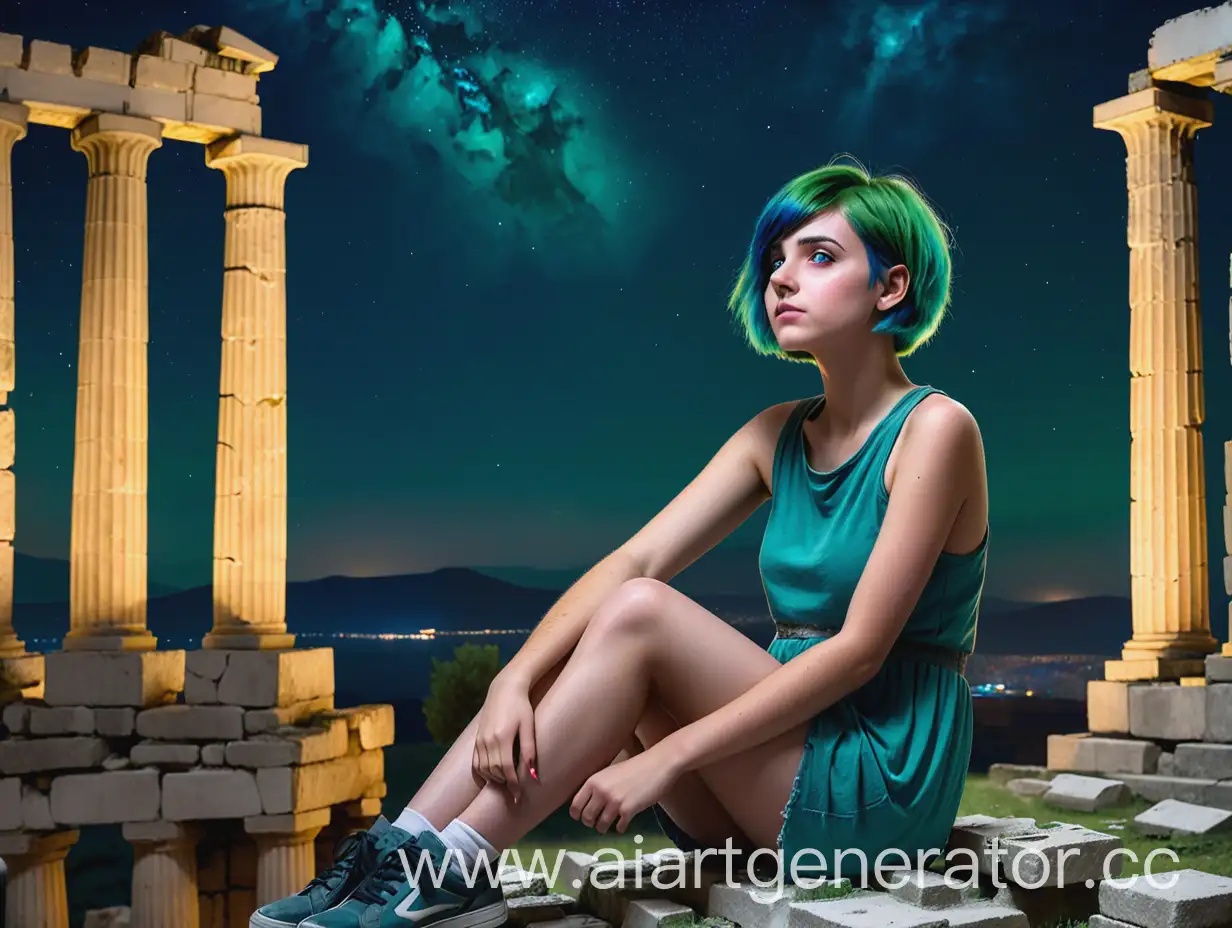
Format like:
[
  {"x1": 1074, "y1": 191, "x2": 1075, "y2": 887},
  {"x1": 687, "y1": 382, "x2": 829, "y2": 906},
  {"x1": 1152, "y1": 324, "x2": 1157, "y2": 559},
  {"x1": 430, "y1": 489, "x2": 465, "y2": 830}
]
[{"x1": 760, "y1": 386, "x2": 988, "y2": 879}]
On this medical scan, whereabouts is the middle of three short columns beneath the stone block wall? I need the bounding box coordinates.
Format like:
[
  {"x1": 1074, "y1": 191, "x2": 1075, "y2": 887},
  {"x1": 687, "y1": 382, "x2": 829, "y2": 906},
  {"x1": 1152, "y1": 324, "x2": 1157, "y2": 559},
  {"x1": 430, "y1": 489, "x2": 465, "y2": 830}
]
[{"x1": 123, "y1": 822, "x2": 201, "y2": 928}]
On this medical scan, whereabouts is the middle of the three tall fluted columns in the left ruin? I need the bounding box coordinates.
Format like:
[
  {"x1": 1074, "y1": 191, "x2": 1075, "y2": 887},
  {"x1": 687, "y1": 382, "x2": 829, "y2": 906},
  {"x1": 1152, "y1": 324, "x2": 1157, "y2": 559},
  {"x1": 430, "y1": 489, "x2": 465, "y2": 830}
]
[{"x1": 64, "y1": 113, "x2": 163, "y2": 651}]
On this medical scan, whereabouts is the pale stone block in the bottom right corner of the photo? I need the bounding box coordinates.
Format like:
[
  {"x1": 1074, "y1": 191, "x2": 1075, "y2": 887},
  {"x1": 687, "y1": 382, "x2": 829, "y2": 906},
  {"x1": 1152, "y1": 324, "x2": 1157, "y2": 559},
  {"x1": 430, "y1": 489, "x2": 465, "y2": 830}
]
[{"x1": 1099, "y1": 869, "x2": 1232, "y2": 928}]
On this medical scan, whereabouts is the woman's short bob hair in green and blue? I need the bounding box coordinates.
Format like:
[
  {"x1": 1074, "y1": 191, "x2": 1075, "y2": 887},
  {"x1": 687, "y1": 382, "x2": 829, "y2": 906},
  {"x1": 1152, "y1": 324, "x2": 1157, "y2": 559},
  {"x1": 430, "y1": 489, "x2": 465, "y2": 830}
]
[{"x1": 728, "y1": 163, "x2": 951, "y2": 361}]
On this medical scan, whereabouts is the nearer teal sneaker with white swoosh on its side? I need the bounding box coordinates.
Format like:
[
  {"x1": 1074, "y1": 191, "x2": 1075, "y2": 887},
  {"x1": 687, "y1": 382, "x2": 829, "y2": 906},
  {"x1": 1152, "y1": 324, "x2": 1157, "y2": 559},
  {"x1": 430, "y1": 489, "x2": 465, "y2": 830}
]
[{"x1": 299, "y1": 832, "x2": 509, "y2": 928}]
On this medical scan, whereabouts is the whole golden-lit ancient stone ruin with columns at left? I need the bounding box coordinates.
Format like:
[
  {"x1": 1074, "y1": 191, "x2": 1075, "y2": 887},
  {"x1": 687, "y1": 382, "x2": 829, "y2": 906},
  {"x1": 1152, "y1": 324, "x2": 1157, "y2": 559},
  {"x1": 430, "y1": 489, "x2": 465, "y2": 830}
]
[{"x1": 0, "y1": 27, "x2": 394, "y2": 928}]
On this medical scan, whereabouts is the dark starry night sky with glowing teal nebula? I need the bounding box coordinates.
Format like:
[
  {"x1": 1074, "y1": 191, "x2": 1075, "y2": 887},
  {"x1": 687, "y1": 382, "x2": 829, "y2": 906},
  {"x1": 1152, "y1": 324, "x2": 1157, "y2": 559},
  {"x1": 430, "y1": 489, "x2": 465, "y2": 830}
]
[{"x1": 0, "y1": 0, "x2": 1232, "y2": 608}]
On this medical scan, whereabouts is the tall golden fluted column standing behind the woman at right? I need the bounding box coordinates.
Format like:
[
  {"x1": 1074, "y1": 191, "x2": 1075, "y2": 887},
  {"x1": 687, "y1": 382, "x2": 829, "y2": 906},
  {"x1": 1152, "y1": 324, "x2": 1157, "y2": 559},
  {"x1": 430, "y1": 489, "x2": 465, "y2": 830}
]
[{"x1": 1094, "y1": 86, "x2": 1218, "y2": 680}]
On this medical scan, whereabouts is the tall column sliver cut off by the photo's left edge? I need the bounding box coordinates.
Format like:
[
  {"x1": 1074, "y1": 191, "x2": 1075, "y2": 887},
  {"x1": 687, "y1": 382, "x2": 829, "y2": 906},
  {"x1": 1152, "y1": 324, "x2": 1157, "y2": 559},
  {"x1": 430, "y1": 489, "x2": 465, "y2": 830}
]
[{"x1": 0, "y1": 102, "x2": 43, "y2": 701}]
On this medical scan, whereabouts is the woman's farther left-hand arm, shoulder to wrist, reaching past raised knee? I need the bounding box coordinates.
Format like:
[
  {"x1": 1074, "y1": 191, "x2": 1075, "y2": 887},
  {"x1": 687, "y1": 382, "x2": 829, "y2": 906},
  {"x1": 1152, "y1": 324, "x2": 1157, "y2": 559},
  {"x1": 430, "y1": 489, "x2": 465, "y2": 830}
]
[{"x1": 500, "y1": 403, "x2": 793, "y2": 688}]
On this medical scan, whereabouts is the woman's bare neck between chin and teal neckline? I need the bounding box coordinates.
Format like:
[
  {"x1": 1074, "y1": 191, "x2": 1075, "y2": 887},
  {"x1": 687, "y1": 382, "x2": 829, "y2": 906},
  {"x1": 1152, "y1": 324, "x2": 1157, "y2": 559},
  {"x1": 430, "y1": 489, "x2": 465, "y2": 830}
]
[{"x1": 817, "y1": 335, "x2": 914, "y2": 435}]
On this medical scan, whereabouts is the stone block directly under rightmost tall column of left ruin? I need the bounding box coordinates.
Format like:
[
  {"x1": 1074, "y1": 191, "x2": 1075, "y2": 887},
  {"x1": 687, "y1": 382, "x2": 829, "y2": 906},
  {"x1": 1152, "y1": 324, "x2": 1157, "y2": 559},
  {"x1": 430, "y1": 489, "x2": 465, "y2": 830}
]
[{"x1": 218, "y1": 648, "x2": 334, "y2": 709}]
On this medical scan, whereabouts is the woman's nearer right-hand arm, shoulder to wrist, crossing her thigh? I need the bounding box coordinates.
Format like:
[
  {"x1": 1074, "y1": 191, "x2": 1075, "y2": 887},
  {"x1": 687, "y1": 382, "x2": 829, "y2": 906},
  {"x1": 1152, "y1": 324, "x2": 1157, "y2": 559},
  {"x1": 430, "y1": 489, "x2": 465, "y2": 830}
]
[{"x1": 652, "y1": 403, "x2": 984, "y2": 773}]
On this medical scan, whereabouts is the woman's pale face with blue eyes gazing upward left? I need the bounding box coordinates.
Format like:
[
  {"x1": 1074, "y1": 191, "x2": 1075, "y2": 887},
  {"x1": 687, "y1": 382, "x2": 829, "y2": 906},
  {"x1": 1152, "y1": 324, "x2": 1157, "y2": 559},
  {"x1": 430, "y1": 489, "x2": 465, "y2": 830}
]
[{"x1": 765, "y1": 210, "x2": 907, "y2": 352}]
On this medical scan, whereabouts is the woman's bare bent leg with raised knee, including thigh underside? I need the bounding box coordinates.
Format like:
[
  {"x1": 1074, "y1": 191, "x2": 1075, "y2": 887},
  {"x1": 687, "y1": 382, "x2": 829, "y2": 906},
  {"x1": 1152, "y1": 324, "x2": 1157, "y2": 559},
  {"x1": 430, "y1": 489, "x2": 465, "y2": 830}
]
[{"x1": 458, "y1": 578, "x2": 807, "y2": 849}]
